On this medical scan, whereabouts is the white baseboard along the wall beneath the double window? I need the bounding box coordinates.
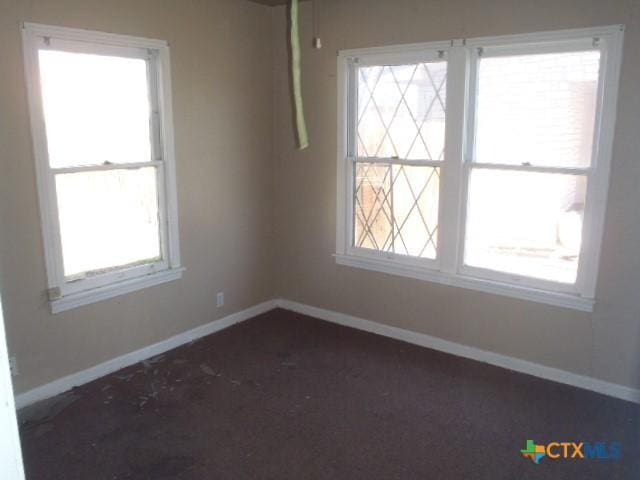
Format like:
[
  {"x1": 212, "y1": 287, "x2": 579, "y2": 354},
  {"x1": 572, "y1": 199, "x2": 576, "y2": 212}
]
[{"x1": 276, "y1": 299, "x2": 640, "y2": 403}]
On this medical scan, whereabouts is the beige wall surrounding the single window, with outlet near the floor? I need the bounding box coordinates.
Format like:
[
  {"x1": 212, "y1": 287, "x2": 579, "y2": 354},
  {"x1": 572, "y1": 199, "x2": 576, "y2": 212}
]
[{"x1": 0, "y1": 0, "x2": 274, "y2": 392}]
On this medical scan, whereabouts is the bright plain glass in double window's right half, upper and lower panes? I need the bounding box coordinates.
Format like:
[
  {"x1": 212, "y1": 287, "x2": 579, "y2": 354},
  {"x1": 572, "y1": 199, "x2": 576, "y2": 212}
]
[{"x1": 465, "y1": 50, "x2": 600, "y2": 284}]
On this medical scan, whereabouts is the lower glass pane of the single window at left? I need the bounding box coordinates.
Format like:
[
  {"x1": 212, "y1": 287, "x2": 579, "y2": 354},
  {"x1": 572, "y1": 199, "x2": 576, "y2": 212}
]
[{"x1": 56, "y1": 167, "x2": 161, "y2": 277}]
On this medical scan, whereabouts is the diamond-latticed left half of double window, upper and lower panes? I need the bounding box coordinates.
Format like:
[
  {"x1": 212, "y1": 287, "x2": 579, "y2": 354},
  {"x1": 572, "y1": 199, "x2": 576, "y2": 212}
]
[{"x1": 352, "y1": 57, "x2": 447, "y2": 259}]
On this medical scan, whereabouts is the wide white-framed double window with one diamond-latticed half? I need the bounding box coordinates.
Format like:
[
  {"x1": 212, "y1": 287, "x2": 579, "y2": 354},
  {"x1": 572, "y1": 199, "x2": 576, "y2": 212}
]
[{"x1": 336, "y1": 26, "x2": 622, "y2": 311}]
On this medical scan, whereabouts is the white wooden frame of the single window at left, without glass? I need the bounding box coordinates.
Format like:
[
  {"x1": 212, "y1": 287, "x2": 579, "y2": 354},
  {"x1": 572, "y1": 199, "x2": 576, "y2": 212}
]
[{"x1": 22, "y1": 23, "x2": 184, "y2": 313}]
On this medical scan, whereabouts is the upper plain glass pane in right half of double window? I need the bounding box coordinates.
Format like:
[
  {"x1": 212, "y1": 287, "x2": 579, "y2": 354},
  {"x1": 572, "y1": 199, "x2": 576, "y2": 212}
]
[{"x1": 476, "y1": 51, "x2": 600, "y2": 167}]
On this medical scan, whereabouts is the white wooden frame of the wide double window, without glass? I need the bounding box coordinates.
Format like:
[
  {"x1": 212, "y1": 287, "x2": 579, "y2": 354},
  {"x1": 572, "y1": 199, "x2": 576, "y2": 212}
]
[{"x1": 335, "y1": 25, "x2": 624, "y2": 312}]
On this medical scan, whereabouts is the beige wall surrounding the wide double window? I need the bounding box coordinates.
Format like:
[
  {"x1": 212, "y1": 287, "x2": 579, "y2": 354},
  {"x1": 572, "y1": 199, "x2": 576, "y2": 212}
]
[{"x1": 273, "y1": 0, "x2": 640, "y2": 388}]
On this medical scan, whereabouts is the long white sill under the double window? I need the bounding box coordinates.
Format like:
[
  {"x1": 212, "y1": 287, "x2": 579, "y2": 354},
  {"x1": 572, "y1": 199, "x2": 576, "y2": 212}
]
[{"x1": 335, "y1": 254, "x2": 595, "y2": 312}]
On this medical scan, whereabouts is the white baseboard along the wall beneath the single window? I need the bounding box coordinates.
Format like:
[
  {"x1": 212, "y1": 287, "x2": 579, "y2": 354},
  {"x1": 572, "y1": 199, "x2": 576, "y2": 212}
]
[{"x1": 16, "y1": 300, "x2": 276, "y2": 409}]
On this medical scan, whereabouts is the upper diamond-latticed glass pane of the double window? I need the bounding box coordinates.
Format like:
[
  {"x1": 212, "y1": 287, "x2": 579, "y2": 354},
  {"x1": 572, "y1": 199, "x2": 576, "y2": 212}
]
[{"x1": 357, "y1": 62, "x2": 447, "y2": 160}]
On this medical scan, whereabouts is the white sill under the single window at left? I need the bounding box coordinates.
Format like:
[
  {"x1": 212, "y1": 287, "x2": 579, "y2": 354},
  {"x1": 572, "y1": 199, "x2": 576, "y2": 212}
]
[{"x1": 50, "y1": 267, "x2": 185, "y2": 314}]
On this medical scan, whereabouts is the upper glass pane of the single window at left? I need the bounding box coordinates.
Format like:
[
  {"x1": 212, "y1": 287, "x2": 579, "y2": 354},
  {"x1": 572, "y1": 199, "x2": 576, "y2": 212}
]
[{"x1": 39, "y1": 50, "x2": 151, "y2": 168}]
